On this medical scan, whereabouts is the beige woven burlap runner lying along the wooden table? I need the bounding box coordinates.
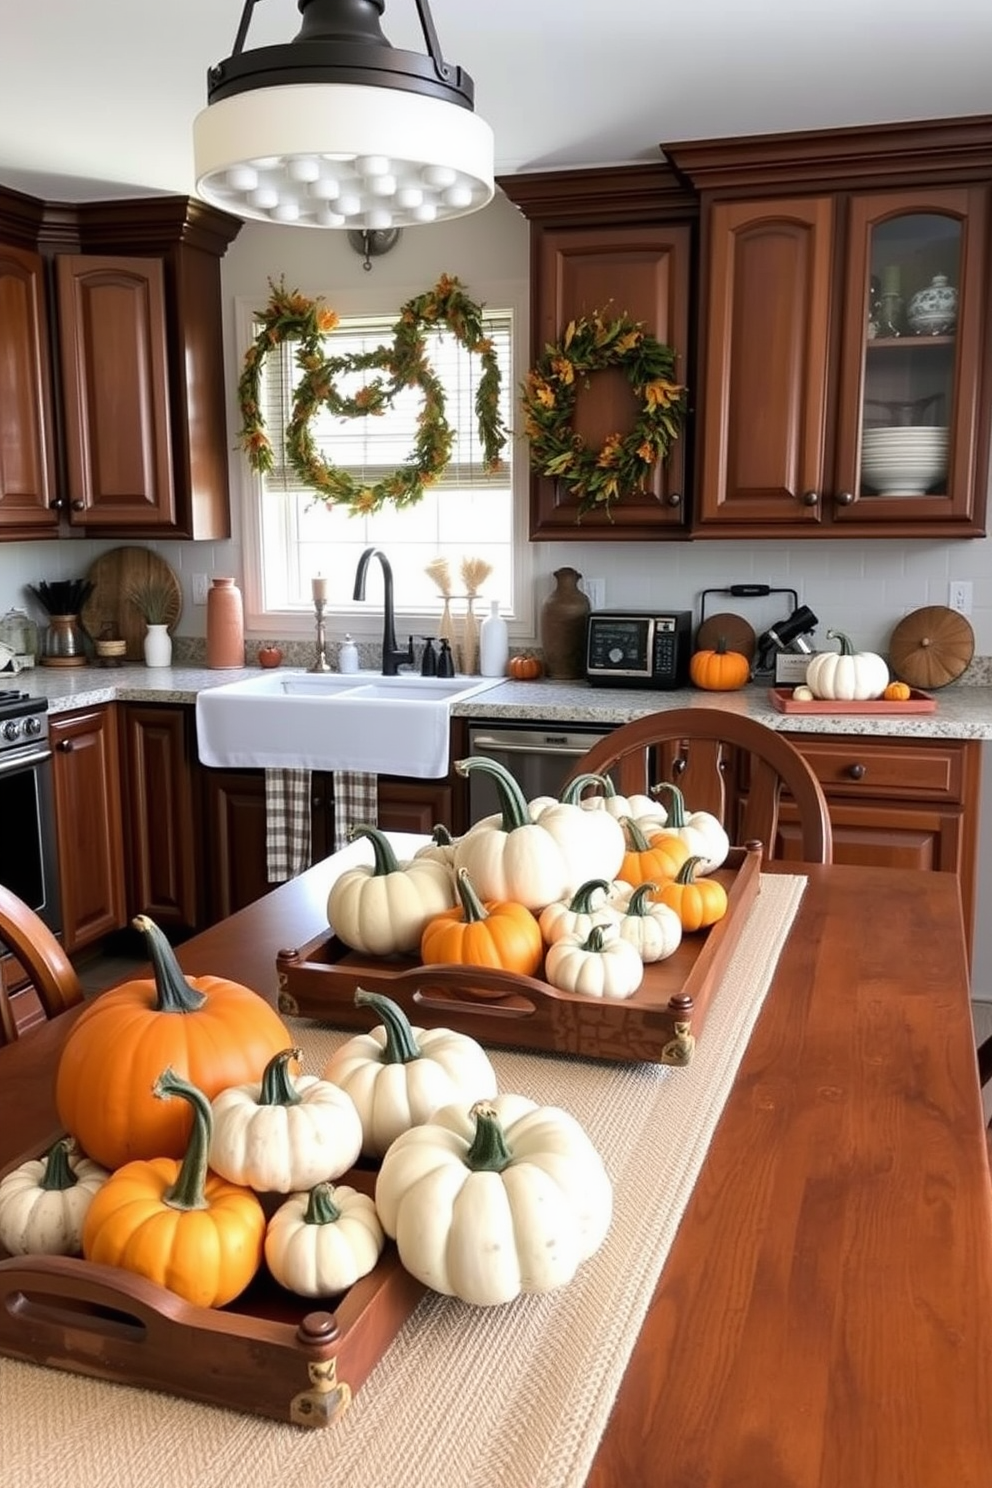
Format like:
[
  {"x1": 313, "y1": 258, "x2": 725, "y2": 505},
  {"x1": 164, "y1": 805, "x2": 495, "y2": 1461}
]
[{"x1": 0, "y1": 875, "x2": 806, "y2": 1488}]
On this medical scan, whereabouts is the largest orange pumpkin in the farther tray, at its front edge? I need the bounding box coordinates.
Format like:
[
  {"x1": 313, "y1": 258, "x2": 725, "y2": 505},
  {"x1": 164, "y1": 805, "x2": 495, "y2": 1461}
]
[{"x1": 421, "y1": 868, "x2": 544, "y2": 976}]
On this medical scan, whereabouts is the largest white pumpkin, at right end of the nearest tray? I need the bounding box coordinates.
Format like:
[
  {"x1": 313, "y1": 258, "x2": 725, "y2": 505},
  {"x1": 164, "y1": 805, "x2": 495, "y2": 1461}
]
[{"x1": 375, "y1": 1095, "x2": 613, "y2": 1306}]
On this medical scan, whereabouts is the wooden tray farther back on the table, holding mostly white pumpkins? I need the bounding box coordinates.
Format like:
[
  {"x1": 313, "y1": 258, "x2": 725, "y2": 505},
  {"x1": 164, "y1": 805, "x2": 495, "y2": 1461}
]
[{"x1": 275, "y1": 842, "x2": 763, "y2": 1065}]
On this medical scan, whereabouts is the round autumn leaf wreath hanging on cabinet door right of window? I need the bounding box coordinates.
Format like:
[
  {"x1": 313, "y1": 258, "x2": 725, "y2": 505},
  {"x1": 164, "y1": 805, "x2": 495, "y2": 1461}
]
[{"x1": 522, "y1": 311, "x2": 686, "y2": 519}]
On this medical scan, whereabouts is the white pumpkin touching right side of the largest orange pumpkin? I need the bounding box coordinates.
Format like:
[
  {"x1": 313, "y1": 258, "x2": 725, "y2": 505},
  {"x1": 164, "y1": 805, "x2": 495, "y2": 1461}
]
[{"x1": 208, "y1": 1049, "x2": 361, "y2": 1193}]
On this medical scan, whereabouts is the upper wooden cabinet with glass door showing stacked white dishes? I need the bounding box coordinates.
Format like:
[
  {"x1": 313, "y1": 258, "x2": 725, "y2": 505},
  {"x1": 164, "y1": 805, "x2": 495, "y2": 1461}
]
[{"x1": 665, "y1": 119, "x2": 992, "y2": 537}]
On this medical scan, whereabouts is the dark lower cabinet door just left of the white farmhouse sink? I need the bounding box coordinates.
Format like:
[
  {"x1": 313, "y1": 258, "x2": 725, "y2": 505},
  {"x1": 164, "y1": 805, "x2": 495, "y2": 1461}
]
[{"x1": 119, "y1": 702, "x2": 202, "y2": 931}]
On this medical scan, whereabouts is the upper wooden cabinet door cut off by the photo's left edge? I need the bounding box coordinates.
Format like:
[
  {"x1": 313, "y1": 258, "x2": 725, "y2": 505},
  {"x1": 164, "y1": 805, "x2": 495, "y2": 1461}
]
[{"x1": 0, "y1": 232, "x2": 58, "y2": 537}]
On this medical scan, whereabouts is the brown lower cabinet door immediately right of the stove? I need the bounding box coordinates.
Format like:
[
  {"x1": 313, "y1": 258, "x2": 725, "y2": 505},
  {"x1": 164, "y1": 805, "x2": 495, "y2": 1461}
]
[{"x1": 49, "y1": 704, "x2": 126, "y2": 952}]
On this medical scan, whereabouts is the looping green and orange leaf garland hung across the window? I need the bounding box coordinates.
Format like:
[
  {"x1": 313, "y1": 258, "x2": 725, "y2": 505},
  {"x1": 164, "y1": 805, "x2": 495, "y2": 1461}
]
[{"x1": 238, "y1": 274, "x2": 507, "y2": 515}]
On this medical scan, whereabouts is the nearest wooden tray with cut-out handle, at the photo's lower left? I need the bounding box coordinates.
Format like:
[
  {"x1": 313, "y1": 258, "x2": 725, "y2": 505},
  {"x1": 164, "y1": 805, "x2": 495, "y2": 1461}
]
[{"x1": 0, "y1": 1152, "x2": 425, "y2": 1427}]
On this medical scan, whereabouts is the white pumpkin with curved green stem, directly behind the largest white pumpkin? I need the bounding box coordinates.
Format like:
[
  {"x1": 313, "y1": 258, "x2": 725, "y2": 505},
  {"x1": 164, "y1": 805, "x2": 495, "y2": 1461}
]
[{"x1": 324, "y1": 988, "x2": 498, "y2": 1158}]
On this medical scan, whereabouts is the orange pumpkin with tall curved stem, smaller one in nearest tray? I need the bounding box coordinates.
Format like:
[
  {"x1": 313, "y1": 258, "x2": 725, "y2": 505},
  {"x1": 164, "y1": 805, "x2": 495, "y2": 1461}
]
[{"x1": 83, "y1": 1070, "x2": 265, "y2": 1306}]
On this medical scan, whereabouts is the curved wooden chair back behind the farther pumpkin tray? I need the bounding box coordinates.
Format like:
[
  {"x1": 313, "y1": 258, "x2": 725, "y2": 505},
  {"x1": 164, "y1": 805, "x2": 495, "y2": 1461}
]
[{"x1": 568, "y1": 707, "x2": 833, "y2": 863}]
